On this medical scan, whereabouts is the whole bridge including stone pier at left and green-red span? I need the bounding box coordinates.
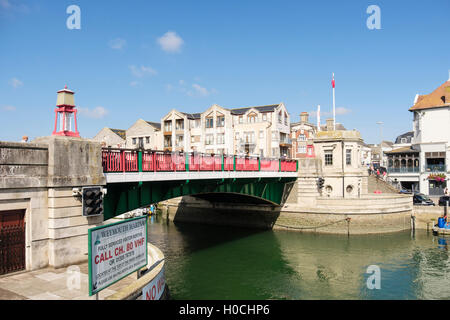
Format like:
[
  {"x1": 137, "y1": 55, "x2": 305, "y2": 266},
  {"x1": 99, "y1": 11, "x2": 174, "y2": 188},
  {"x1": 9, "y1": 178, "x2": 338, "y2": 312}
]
[{"x1": 0, "y1": 136, "x2": 297, "y2": 274}]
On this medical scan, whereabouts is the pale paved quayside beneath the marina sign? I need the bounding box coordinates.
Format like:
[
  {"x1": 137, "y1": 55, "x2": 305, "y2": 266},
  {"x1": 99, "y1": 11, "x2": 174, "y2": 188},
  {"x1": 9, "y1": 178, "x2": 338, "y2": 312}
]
[{"x1": 0, "y1": 262, "x2": 137, "y2": 300}]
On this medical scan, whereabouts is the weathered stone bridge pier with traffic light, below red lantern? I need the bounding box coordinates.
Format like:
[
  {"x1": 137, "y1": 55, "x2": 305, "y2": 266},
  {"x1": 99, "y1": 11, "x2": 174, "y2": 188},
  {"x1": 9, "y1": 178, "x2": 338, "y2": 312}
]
[{"x1": 0, "y1": 136, "x2": 106, "y2": 270}]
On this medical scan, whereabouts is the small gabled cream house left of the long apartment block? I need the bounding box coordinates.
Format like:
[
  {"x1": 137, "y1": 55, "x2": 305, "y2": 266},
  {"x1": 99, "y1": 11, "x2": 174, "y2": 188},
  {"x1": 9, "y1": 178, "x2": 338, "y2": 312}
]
[{"x1": 125, "y1": 119, "x2": 162, "y2": 150}]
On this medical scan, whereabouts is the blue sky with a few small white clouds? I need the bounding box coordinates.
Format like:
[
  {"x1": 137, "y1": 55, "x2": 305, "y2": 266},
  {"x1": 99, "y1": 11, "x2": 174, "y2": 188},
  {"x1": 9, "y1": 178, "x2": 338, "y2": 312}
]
[{"x1": 0, "y1": 0, "x2": 450, "y2": 143}]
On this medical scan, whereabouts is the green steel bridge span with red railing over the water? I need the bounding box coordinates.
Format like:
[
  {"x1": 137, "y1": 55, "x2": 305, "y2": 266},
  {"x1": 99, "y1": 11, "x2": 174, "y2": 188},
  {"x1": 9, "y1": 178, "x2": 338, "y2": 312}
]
[{"x1": 102, "y1": 148, "x2": 298, "y2": 219}]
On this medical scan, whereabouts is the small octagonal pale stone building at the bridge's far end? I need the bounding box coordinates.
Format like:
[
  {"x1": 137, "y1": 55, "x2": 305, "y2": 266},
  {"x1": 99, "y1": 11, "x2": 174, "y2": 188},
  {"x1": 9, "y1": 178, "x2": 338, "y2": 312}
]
[{"x1": 314, "y1": 119, "x2": 368, "y2": 198}]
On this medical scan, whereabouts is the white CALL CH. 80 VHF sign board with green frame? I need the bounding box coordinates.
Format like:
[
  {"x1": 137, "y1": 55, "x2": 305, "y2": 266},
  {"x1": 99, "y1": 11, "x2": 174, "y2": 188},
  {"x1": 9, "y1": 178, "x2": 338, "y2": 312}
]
[{"x1": 89, "y1": 216, "x2": 147, "y2": 295}]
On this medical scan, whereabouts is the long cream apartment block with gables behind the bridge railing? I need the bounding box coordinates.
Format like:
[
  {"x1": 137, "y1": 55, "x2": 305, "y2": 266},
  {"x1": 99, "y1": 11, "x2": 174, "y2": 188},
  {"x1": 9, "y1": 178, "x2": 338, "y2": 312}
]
[{"x1": 161, "y1": 103, "x2": 291, "y2": 157}]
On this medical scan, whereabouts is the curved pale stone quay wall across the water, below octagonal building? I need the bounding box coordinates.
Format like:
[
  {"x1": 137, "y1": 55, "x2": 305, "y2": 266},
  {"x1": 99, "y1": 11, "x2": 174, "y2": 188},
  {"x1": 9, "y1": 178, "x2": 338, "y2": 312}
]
[{"x1": 158, "y1": 194, "x2": 418, "y2": 234}]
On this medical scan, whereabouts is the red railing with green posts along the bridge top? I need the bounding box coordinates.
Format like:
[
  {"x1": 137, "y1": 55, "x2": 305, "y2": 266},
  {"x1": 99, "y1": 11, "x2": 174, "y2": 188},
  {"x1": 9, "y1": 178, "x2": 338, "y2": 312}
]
[{"x1": 102, "y1": 148, "x2": 298, "y2": 173}]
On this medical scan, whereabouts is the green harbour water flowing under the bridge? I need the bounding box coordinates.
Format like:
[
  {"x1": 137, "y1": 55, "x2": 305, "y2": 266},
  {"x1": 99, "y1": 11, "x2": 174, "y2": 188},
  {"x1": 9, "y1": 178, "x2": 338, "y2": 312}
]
[{"x1": 148, "y1": 217, "x2": 450, "y2": 300}]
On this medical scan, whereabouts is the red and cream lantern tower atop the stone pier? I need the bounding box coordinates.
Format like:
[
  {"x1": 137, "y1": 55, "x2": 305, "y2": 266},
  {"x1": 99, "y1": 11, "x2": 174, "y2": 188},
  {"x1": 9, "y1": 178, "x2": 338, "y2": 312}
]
[{"x1": 52, "y1": 86, "x2": 80, "y2": 137}]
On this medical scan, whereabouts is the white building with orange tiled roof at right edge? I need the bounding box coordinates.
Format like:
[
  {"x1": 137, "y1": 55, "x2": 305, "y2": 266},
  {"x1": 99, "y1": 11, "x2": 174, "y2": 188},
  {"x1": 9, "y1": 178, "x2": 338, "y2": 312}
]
[{"x1": 409, "y1": 79, "x2": 450, "y2": 195}]
